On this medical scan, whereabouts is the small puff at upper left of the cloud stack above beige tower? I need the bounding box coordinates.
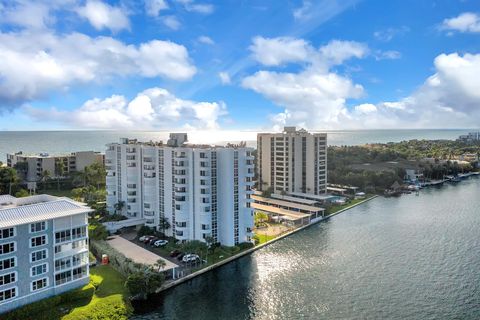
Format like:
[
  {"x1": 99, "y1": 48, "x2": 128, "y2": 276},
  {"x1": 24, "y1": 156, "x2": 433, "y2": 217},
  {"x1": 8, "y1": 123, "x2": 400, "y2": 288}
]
[{"x1": 250, "y1": 37, "x2": 313, "y2": 66}]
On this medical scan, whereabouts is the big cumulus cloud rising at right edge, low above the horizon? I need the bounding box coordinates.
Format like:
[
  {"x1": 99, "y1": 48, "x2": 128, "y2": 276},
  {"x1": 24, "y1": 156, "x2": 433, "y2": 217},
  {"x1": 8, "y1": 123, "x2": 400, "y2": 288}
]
[{"x1": 343, "y1": 53, "x2": 480, "y2": 128}]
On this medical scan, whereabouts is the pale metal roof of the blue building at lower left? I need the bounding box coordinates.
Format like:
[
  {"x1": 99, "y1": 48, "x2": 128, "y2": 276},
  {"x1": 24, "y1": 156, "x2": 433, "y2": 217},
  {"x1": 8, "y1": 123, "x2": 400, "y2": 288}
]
[{"x1": 0, "y1": 194, "x2": 93, "y2": 228}]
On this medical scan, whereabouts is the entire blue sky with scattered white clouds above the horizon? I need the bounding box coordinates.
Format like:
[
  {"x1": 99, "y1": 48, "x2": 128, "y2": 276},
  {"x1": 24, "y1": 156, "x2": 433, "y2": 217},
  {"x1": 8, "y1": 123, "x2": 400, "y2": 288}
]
[{"x1": 0, "y1": 0, "x2": 480, "y2": 132}]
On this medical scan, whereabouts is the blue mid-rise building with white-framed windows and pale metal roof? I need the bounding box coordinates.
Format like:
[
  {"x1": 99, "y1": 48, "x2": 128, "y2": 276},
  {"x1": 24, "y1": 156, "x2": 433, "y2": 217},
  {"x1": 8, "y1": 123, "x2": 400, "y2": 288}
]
[{"x1": 0, "y1": 195, "x2": 92, "y2": 318}]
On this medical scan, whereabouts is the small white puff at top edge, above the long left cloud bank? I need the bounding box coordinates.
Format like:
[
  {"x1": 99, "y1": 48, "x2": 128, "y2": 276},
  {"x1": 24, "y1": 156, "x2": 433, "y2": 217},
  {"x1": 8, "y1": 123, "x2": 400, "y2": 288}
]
[{"x1": 77, "y1": 0, "x2": 130, "y2": 32}]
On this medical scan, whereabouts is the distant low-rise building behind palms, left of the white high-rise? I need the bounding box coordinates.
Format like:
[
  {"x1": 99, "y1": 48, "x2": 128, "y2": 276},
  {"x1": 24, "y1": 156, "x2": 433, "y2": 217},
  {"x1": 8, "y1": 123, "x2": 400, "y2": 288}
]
[{"x1": 7, "y1": 151, "x2": 105, "y2": 182}]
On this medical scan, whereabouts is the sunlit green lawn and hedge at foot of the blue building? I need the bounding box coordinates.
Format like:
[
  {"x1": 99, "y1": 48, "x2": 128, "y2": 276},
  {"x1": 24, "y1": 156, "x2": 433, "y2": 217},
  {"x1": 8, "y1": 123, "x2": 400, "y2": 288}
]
[{"x1": 0, "y1": 266, "x2": 133, "y2": 320}]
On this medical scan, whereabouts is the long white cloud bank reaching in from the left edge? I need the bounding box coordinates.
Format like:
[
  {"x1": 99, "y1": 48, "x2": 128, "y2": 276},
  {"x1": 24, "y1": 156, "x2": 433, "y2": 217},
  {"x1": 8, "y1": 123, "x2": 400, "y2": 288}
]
[{"x1": 0, "y1": 31, "x2": 196, "y2": 106}]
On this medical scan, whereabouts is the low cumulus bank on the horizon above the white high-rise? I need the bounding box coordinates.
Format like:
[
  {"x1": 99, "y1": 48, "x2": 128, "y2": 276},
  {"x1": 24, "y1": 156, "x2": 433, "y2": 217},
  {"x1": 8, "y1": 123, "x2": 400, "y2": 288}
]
[{"x1": 24, "y1": 87, "x2": 227, "y2": 130}]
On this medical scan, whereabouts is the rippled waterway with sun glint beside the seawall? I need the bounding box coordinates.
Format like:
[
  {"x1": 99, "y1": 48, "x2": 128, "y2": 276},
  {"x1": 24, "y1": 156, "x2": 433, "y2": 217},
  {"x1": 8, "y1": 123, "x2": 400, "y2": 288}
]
[{"x1": 133, "y1": 178, "x2": 480, "y2": 320}]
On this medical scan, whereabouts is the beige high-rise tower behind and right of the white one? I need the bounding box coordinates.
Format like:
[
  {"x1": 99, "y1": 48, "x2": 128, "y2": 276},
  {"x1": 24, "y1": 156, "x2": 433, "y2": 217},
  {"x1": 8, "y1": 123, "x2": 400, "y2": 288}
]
[{"x1": 257, "y1": 127, "x2": 327, "y2": 195}]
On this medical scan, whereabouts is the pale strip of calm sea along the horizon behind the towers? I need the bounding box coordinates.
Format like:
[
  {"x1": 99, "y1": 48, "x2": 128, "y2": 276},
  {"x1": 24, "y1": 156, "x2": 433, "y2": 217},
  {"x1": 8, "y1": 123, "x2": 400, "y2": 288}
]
[{"x1": 0, "y1": 130, "x2": 471, "y2": 161}]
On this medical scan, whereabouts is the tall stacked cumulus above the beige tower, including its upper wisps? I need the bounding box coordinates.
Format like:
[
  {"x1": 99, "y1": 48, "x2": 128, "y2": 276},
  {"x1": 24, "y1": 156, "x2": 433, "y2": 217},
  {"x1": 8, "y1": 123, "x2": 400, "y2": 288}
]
[{"x1": 242, "y1": 38, "x2": 369, "y2": 127}]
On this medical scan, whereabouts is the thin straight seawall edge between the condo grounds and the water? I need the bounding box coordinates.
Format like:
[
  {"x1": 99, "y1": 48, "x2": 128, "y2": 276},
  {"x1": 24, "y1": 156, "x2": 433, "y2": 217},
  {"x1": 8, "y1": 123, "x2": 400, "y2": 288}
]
[{"x1": 155, "y1": 195, "x2": 379, "y2": 294}]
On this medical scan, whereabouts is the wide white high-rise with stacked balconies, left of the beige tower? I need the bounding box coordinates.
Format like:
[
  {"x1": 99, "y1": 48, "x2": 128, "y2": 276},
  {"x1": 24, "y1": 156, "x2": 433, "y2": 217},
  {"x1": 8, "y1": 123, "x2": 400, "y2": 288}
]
[{"x1": 105, "y1": 134, "x2": 254, "y2": 246}]
